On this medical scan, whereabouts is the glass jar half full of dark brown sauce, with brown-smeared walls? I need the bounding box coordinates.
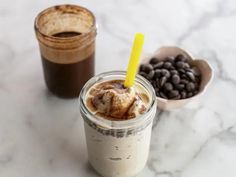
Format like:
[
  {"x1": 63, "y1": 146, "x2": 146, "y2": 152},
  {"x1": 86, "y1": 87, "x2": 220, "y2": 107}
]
[{"x1": 34, "y1": 5, "x2": 97, "y2": 98}]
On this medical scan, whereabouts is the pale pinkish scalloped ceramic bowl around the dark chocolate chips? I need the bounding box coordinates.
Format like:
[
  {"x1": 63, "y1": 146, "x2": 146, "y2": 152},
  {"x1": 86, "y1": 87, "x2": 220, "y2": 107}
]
[{"x1": 140, "y1": 47, "x2": 213, "y2": 110}]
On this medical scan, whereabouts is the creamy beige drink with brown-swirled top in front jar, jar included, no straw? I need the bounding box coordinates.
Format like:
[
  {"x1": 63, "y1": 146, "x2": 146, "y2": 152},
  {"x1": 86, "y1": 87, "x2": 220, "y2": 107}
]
[{"x1": 80, "y1": 72, "x2": 156, "y2": 177}]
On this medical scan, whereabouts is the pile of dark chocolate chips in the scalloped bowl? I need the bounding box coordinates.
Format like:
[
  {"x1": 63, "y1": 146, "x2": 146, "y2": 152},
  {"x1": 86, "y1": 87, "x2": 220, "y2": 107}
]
[{"x1": 139, "y1": 54, "x2": 201, "y2": 100}]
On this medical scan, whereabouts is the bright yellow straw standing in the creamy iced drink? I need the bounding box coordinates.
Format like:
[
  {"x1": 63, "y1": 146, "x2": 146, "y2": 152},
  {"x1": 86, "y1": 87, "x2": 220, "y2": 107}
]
[{"x1": 124, "y1": 33, "x2": 144, "y2": 87}]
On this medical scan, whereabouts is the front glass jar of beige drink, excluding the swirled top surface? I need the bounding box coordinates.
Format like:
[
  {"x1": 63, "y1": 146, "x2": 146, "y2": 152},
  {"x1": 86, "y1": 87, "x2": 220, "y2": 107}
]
[{"x1": 79, "y1": 71, "x2": 156, "y2": 177}]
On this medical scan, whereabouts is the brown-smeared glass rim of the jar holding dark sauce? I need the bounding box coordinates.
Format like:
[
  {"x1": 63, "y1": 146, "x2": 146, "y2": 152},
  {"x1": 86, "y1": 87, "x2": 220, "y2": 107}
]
[{"x1": 34, "y1": 4, "x2": 97, "y2": 41}]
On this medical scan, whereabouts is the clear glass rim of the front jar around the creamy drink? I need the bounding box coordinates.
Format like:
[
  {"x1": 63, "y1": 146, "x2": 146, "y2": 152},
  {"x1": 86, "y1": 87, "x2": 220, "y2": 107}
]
[{"x1": 79, "y1": 71, "x2": 157, "y2": 129}]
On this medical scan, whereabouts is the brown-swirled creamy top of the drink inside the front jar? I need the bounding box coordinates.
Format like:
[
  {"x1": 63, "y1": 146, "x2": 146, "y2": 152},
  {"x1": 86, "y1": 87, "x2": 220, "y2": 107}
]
[{"x1": 86, "y1": 80, "x2": 150, "y2": 120}]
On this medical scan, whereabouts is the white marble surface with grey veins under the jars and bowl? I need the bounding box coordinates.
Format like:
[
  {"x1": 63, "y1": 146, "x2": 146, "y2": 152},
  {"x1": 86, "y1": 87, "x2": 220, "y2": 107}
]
[{"x1": 0, "y1": 0, "x2": 236, "y2": 177}]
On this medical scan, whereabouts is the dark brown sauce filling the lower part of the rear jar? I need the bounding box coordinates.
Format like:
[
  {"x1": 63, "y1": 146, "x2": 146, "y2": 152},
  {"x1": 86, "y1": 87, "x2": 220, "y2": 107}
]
[{"x1": 42, "y1": 53, "x2": 94, "y2": 98}]
